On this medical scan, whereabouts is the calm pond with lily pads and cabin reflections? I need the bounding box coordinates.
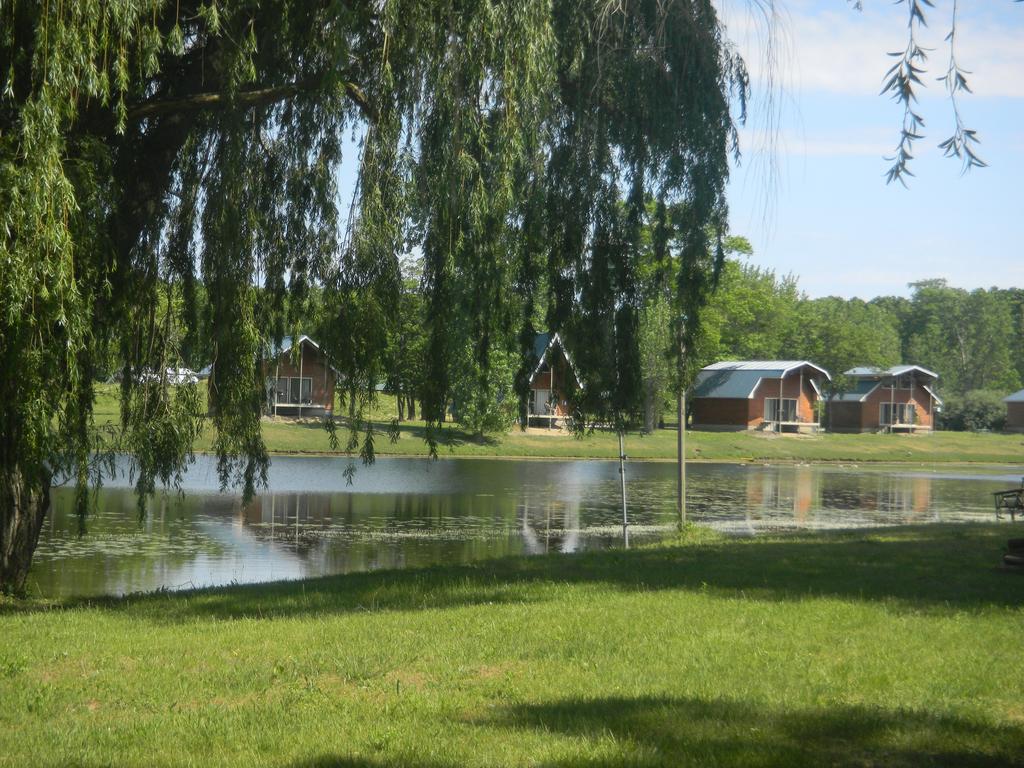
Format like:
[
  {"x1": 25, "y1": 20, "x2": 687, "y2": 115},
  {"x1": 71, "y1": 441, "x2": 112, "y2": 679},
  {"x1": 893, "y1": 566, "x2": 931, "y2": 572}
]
[{"x1": 30, "y1": 457, "x2": 1024, "y2": 597}]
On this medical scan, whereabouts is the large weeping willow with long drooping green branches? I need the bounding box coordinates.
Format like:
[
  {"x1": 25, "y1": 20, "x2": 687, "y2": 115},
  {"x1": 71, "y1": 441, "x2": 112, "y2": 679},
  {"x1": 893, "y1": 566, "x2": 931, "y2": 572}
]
[{"x1": 0, "y1": 0, "x2": 746, "y2": 591}]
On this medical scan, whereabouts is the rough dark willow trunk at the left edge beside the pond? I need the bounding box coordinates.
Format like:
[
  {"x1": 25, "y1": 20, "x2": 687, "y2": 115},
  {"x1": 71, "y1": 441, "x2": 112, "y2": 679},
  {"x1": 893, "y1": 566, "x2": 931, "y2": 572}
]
[{"x1": 0, "y1": 467, "x2": 50, "y2": 594}]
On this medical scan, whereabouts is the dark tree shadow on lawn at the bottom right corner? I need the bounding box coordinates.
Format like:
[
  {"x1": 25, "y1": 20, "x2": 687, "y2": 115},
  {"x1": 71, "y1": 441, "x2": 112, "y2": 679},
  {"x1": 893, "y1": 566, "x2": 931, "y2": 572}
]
[{"x1": 468, "y1": 697, "x2": 1024, "y2": 768}]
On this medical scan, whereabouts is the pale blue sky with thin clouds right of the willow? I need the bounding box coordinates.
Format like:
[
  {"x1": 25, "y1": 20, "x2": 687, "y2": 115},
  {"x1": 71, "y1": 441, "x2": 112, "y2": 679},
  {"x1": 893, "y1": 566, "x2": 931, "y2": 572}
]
[{"x1": 718, "y1": 0, "x2": 1024, "y2": 299}]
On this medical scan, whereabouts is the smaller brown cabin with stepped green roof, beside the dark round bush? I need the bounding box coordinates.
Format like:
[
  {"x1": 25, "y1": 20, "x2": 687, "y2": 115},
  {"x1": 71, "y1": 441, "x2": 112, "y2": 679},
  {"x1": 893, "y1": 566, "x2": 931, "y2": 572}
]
[{"x1": 828, "y1": 366, "x2": 942, "y2": 432}]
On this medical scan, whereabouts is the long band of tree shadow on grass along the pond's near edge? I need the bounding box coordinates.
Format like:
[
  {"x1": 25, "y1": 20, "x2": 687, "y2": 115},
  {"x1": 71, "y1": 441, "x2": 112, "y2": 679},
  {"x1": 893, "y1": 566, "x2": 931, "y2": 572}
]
[{"x1": 0, "y1": 524, "x2": 1024, "y2": 623}]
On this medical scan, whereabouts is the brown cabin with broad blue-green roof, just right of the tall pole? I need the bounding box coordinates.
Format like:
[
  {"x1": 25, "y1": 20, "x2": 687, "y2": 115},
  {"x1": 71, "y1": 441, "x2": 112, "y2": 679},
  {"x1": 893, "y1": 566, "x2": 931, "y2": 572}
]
[{"x1": 690, "y1": 360, "x2": 829, "y2": 432}]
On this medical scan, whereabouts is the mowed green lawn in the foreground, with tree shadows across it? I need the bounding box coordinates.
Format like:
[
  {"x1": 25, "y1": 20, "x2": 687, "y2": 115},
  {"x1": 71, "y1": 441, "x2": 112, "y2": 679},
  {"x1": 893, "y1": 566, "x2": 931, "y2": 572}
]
[{"x1": 0, "y1": 523, "x2": 1024, "y2": 768}]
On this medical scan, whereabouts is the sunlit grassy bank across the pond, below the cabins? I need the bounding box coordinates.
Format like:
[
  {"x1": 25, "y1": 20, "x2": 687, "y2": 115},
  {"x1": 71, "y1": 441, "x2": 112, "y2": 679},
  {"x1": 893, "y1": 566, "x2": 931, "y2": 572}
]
[{"x1": 90, "y1": 385, "x2": 1024, "y2": 464}]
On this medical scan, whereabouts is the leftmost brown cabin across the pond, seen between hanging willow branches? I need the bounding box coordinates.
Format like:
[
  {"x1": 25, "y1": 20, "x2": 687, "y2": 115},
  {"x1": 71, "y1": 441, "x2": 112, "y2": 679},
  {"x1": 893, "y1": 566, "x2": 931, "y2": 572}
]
[{"x1": 268, "y1": 335, "x2": 337, "y2": 417}]
